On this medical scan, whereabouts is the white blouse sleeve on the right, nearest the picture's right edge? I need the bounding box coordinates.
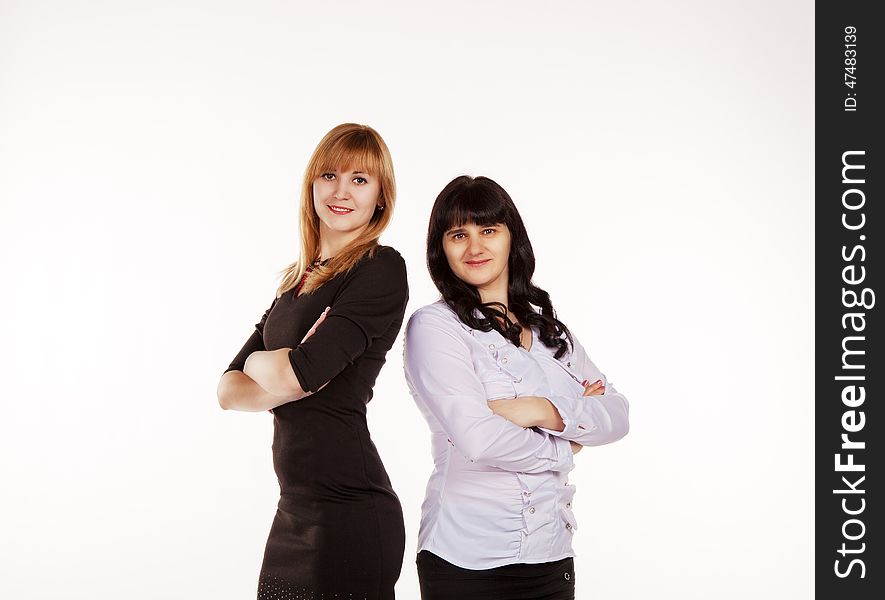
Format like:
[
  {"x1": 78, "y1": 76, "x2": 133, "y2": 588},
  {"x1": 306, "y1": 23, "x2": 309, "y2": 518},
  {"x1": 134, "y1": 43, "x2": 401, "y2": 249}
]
[{"x1": 544, "y1": 336, "x2": 630, "y2": 446}]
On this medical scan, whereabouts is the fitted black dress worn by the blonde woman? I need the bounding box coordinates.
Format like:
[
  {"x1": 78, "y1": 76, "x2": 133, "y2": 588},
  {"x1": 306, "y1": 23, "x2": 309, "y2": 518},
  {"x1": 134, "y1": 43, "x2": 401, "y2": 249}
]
[{"x1": 228, "y1": 246, "x2": 408, "y2": 600}]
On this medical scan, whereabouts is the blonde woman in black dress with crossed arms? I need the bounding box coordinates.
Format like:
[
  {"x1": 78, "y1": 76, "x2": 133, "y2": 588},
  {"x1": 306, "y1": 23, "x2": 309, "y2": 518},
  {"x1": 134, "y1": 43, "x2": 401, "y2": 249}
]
[{"x1": 218, "y1": 123, "x2": 408, "y2": 600}]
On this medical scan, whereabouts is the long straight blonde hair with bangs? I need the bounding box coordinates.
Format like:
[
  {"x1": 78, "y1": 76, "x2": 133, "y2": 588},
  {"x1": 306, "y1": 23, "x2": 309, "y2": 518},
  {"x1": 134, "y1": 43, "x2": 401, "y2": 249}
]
[{"x1": 277, "y1": 123, "x2": 396, "y2": 297}]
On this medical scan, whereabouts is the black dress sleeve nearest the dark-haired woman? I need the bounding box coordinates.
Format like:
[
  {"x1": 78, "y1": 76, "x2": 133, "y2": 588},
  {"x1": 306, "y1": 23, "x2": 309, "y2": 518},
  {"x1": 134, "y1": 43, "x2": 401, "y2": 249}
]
[{"x1": 289, "y1": 247, "x2": 409, "y2": 392}]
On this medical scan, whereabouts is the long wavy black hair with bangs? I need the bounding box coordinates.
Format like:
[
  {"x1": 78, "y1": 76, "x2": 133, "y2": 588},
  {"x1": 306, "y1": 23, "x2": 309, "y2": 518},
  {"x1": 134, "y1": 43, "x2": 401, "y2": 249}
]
[{"x1": 427, "y1": 175, "x2": 572, "y2": 358}]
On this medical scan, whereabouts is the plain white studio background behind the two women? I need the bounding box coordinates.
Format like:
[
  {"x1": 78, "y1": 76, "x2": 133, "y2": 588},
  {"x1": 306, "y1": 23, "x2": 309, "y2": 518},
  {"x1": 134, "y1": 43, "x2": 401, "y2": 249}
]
[{"x1": 0, "y1": 0, "x2": 814, "y2": 600}]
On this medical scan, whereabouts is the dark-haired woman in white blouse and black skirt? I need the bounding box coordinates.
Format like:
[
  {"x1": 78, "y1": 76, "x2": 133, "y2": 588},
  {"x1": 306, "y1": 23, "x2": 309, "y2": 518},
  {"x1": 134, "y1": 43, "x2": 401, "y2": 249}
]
[{"x1": 404, "y1": 177, "x2": 628, "y2": 600}]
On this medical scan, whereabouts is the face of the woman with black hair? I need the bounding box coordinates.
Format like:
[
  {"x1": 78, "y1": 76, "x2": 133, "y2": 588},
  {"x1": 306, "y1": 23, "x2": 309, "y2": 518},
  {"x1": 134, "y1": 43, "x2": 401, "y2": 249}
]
[{"x1": 443, "y1": 223, "x2": 510, "y2": 290}]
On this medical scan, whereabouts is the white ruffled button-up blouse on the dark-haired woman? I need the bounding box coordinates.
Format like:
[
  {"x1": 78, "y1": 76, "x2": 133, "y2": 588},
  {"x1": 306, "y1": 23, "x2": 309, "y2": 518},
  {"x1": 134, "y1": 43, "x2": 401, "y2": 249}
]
[{"x1": 403, "y1": 301, "x2": 628, "y2": 569}]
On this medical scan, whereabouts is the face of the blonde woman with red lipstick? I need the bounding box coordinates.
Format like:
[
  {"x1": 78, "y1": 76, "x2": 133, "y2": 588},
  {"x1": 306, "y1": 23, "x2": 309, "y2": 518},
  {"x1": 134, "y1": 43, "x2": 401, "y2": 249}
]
[{"x1": 313, "y1": 168, "x2": 381, "y2": 236}]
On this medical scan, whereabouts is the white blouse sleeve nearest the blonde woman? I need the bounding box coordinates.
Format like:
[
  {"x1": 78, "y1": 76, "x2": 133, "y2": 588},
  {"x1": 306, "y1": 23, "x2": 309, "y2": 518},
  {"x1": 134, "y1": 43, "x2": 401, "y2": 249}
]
[{"x1": 403, "y1": 311, "x2": 574, "y2": 473}]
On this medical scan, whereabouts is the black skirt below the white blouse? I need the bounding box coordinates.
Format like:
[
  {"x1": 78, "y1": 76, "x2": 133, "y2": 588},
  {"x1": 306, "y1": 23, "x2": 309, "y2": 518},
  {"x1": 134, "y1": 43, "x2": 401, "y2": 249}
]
[{"x1": 416, "y1": 550, "x2": 575, "y2": 600}]
